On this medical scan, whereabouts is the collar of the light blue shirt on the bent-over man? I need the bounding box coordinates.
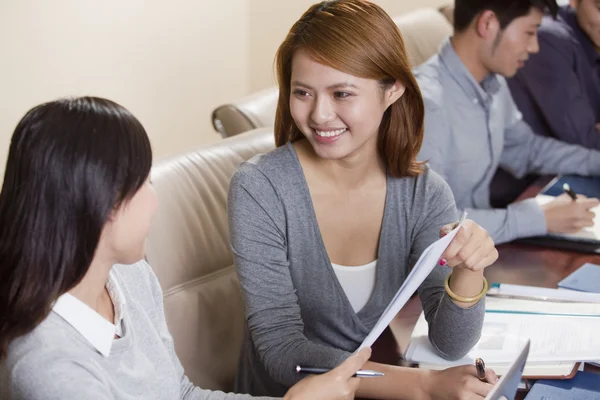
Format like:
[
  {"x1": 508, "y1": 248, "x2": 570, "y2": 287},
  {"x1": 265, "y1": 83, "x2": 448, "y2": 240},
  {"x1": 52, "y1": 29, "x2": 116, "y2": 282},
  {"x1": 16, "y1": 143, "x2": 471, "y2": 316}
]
[{"x1": 440, "y1": 38, "x2": 500, "y2": 103}]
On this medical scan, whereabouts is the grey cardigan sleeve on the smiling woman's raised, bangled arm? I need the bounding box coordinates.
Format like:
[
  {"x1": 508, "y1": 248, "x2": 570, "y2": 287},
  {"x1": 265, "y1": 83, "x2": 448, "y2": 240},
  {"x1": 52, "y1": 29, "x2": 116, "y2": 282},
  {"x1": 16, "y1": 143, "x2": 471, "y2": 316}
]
[{"x1": 410, "y1": 171, "x2": 485, "y2": 360}]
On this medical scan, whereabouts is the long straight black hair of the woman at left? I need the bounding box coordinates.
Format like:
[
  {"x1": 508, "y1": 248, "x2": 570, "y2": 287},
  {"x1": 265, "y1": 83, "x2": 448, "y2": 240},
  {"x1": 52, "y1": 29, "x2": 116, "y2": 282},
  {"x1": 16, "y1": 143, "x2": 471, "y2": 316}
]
[{"x1": 0, "y1": 97, "x2": 152, "y2": 359}]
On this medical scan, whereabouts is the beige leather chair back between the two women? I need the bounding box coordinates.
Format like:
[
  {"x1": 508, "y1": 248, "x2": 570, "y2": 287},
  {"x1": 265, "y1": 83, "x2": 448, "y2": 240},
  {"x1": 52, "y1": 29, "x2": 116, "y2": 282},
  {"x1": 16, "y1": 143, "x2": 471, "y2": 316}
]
[{"x1": 147, "y1": 129, "x2": 274, "y2": 391}]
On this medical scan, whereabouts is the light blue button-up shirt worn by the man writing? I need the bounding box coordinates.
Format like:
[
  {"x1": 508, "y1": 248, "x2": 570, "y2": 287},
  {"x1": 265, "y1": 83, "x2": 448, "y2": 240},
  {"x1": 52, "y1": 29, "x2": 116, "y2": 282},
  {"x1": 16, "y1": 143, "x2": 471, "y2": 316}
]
[{"x1": 415, "y1": 40, "x2": 600, "y2": 243}]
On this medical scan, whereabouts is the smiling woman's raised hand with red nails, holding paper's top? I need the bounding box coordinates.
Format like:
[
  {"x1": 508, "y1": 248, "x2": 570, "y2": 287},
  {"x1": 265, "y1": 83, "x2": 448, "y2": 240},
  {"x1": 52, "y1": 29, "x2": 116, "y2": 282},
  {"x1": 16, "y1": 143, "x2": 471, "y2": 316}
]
[{"x1": 440, "y1": 219, "x2": 498, "y2": 271}]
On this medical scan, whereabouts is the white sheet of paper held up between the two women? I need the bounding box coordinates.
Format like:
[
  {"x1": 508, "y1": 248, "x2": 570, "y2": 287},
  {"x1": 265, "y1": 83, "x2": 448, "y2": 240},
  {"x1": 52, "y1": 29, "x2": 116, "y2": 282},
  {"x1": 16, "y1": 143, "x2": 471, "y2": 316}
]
[{"x1": 359, "y1": 212, "x2": 467, "y2": 349}]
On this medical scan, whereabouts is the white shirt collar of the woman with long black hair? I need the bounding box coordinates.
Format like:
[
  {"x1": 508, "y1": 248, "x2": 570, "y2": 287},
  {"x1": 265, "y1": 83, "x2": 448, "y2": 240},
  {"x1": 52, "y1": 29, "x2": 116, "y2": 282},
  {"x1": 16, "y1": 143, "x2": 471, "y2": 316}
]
[{"x1": 52, "y1": 270, "x2": 127, "y2": 357}]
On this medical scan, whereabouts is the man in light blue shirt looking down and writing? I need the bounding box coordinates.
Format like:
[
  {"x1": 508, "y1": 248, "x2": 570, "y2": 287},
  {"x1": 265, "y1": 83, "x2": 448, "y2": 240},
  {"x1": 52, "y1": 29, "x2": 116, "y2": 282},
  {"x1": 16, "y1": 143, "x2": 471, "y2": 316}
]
[{"x1": 416, "y1": 0, "x2": 600, "y2": 243}]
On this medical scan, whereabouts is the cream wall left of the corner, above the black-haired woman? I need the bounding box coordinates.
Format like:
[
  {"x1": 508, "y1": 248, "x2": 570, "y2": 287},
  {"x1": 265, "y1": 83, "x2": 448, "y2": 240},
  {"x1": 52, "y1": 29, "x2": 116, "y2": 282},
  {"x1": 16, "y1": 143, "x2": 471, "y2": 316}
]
[{"x1": 0, "y1": 0, "x2": 248, "y2": 182}]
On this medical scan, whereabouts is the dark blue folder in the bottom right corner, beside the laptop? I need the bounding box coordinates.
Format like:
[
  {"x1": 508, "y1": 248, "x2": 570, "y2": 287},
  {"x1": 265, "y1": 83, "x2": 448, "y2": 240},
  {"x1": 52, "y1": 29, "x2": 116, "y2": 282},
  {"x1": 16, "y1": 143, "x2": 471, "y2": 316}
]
[{"x1": 525, "y1": 371, "x2": 600, "y2": 400}]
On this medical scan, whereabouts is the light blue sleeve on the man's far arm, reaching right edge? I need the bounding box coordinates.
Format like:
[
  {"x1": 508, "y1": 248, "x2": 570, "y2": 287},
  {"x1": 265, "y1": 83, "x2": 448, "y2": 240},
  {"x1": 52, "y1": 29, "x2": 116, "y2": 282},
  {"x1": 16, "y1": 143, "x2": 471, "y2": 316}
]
[{"x1": 500, "y1": 92, "x2": 600, "y2": 178}]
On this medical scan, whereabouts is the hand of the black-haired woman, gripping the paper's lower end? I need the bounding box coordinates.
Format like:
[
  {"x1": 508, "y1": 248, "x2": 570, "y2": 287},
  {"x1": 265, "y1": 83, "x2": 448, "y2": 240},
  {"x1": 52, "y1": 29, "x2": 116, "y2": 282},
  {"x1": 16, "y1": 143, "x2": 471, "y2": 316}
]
[{"x1": 284, "y1": 348, "x2": 371, "y2": 400}]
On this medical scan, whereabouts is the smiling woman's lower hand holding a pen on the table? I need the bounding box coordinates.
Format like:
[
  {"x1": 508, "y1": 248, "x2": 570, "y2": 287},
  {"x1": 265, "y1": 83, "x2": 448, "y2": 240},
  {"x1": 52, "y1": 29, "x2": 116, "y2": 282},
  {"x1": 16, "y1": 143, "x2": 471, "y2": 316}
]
[{"x1": 420, "y1": 365, "x2": 498, "y2": 400}]
